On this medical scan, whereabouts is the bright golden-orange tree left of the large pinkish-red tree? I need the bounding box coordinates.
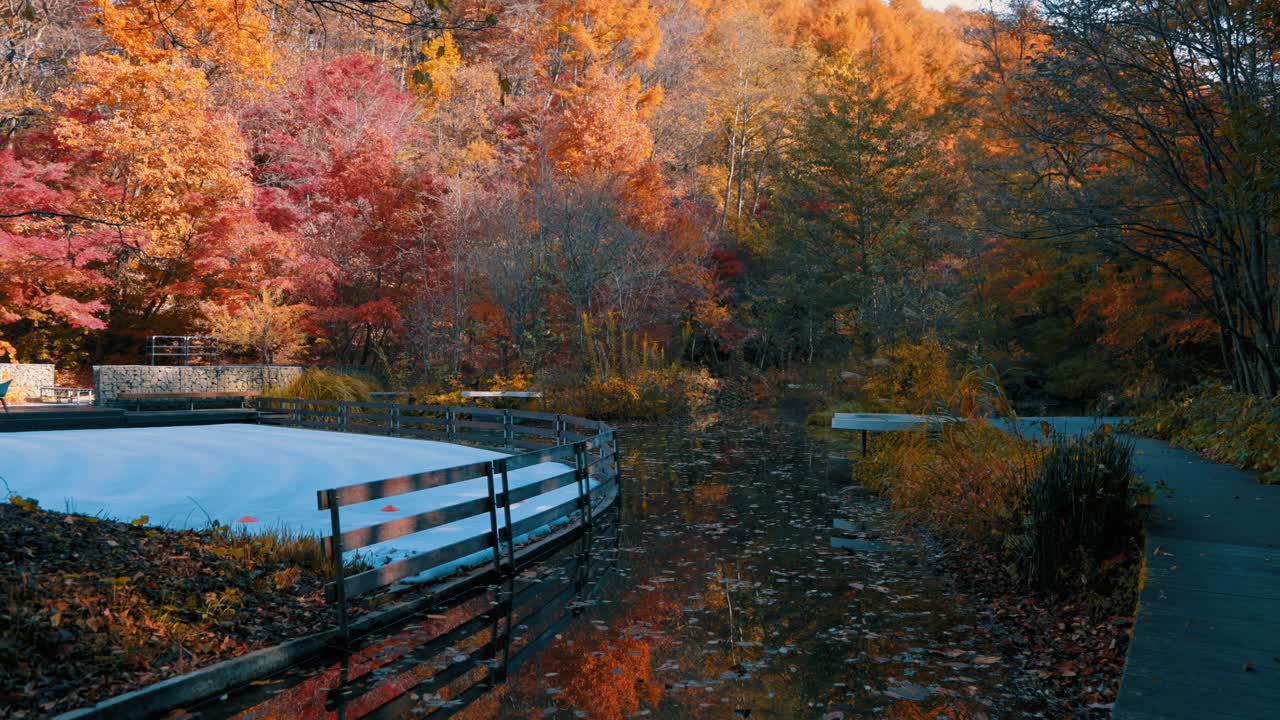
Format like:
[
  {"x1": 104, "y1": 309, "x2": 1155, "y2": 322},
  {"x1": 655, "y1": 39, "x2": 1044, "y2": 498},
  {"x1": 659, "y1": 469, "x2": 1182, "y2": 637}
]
[{"x1": 54, "y1": 54, "x2": 277, "y2": 356}]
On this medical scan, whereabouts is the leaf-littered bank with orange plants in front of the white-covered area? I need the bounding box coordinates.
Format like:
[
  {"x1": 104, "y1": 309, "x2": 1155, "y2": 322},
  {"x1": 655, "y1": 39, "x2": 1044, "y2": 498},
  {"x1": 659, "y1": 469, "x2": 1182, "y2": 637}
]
[{"x1": 0, "y1": 497, "x2": 337, "y2": 717}]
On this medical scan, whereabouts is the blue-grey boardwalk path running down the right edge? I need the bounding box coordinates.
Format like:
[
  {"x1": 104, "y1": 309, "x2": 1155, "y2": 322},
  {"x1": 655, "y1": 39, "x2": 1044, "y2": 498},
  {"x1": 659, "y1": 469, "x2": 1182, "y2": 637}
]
[{"x1": 1114, "y1": 439, "x2": 1280, "y2": 720}]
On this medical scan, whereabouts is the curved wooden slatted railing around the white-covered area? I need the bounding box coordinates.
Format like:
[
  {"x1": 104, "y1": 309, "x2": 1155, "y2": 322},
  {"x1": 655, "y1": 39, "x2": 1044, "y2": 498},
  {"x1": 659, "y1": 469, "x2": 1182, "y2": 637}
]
[{"x1": 256, "y1": 397, "x2": 621, "y2": 638}]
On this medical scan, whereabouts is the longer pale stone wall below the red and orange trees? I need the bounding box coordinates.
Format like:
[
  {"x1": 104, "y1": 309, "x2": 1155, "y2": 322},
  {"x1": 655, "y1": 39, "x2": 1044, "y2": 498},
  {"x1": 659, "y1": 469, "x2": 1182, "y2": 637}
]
[{"x1": 93, "y1": 365, "x2": 302, "y2": 405}]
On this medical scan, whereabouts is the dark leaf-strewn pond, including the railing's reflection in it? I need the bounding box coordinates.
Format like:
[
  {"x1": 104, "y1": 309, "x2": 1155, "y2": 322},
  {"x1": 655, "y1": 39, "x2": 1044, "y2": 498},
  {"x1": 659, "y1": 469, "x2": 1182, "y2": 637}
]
[{"x1": 193, "y1": 413, "x2": 1048, "y2": 720}]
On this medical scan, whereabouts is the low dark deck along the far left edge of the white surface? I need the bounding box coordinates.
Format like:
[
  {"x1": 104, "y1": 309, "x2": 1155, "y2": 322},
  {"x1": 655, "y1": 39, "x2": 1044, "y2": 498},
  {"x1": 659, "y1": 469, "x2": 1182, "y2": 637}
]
[{"x1": 0, "y1": 405, "x2": 257, "y2": 433}]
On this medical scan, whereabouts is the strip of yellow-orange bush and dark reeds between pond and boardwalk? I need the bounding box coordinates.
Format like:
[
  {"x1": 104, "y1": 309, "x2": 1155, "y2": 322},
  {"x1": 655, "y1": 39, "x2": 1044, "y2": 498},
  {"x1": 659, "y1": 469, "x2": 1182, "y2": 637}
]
[{"x1": 852, "y1": 420, "x2": 1148, "y2": 714}]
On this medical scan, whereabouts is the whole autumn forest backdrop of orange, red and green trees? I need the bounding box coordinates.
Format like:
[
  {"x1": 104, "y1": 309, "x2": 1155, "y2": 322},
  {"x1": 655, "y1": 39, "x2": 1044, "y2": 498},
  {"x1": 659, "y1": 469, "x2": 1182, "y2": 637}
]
[{"x1": 0, "y1": 0, "x2": 1280, "y2": 416}]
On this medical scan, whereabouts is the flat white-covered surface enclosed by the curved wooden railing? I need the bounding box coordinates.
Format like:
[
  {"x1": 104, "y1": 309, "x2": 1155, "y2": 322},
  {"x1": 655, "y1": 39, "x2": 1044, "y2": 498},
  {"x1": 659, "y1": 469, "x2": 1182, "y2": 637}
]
[{"x1": 0, "y1": 424, "x2": 577, "y2": 577}]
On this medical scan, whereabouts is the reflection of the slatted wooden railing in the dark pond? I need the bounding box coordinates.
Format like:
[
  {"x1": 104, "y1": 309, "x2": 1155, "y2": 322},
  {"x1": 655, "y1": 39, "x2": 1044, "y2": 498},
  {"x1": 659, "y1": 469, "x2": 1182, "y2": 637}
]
[{"x1": 196, "y1": 507, "x2": 621, "y2": 720}]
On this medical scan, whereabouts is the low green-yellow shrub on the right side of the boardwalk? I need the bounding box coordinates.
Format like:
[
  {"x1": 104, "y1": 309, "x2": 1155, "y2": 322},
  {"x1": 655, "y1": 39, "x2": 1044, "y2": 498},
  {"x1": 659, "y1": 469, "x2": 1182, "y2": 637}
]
[{"x1": 1133, "y1": 384, "x2": 1280, "y2": 484}]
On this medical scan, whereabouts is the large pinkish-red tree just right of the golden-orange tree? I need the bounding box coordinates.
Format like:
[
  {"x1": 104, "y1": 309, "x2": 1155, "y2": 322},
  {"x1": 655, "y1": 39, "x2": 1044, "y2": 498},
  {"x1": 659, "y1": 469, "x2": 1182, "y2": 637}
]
[{"x1": 244, "y1": 55, "x2": 443, "y2": 364}]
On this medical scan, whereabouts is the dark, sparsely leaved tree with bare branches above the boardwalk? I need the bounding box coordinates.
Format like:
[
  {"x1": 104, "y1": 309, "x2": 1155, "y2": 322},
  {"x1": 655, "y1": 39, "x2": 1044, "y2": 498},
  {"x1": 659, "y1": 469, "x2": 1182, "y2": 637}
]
[{"x1": 993, "y1": 0, "x2": 1280, "y2": 396}]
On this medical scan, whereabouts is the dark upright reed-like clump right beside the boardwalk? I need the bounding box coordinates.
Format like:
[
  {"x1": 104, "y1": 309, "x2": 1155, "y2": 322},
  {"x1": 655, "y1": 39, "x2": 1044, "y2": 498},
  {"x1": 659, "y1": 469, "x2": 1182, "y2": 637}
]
[{"x1": 1009, "y1": 430, "x2": 1139, "y2": 593}]
